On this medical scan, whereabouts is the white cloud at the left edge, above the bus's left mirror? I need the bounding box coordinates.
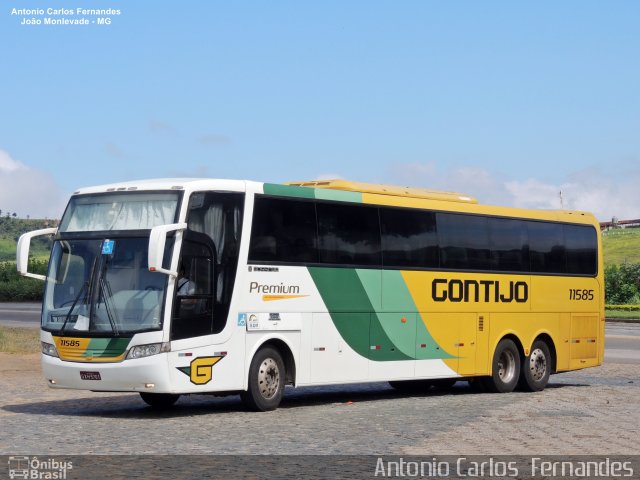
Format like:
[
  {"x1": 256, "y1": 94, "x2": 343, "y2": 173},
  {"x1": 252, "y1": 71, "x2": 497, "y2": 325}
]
[{"x1": 0, "y1": 150, "x2": 68, "y2": 218}]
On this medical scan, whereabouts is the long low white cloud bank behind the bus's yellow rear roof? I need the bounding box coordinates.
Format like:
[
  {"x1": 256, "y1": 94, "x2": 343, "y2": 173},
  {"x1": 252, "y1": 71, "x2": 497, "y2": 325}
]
[{"x1": 391, "y1": 162, "x2": 640, "y2": 221}]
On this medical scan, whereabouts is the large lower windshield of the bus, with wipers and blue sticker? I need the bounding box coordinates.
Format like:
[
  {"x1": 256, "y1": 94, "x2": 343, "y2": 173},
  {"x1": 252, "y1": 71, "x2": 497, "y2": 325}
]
[{"x1": 42, "y1": 237, "x2": 173, "y2": 336}]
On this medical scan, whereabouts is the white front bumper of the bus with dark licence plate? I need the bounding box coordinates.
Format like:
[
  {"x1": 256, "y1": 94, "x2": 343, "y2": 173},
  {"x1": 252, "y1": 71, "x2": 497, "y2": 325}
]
[{"x1": 42, "y1": 353, "x2": 175, "y2": 393}]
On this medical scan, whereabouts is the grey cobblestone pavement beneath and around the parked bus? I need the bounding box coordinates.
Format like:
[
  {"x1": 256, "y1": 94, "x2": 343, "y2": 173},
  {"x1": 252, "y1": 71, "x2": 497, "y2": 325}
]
[{"x1": 0, "y1": 354, "x2": 640, "y2": 455}]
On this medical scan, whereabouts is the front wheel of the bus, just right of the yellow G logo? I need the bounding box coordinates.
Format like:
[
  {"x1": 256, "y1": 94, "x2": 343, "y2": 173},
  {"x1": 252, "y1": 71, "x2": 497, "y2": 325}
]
[{"x1": 240, "y1": 346, "x2": 287, "y2": 412}]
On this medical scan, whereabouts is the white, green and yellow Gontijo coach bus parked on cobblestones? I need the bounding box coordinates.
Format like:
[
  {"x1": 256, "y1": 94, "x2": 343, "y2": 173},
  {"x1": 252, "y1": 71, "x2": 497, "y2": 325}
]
[{"x1": 17, "y1": 179, "x2": 605, "y2": 411}]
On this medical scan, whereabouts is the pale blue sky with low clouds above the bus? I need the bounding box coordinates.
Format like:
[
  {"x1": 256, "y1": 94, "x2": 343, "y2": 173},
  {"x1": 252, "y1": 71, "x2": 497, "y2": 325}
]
[{"x1": 0, "y1": 0, "x2": 640, "y2": 221}]
